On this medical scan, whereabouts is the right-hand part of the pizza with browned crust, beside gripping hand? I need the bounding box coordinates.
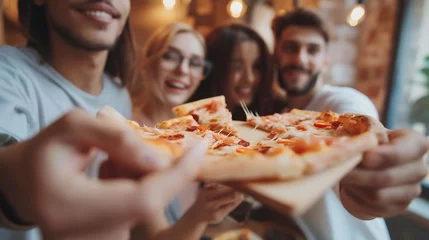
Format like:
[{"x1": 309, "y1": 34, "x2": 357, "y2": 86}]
[{"x1": 246, "y1": 109, "x2": 387, "y2": 174}]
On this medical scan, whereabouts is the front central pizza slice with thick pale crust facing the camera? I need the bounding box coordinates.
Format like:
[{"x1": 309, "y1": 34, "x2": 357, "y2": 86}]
[{"x1": 157, "y1": 116, "x2": 305, "y2": 182}]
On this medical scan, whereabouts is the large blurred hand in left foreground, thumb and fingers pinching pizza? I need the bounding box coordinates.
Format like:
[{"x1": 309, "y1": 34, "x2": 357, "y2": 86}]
[{"x1": 0, "y1": 110, "x2": 206, "y2": 239}]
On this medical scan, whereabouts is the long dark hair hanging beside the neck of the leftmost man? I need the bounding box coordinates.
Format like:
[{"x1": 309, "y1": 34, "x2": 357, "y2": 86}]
[{"x1": 18, "y1": 0, "x2": 138, "y2": 86}]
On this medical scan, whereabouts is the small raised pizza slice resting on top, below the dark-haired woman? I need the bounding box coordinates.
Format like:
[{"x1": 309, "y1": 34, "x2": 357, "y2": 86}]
[{"x1": 173, "y1": 96, "x2": 237, "y2": 135}]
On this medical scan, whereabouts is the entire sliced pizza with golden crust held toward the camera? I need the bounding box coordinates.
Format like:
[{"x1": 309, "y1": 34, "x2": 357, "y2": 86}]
[{"x1": 98, "y1": 96, "x2": 387, "y2": 182}]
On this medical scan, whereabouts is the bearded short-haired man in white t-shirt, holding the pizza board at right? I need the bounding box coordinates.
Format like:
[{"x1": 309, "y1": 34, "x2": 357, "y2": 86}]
[{"x1": 272, "y1": 9, "x2": 427, "y2": 240}]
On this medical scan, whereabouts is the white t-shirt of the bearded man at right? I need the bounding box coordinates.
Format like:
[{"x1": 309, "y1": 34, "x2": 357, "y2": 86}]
[{"x1": 296, "y1": 85, "x2": 390, "y2": 240}]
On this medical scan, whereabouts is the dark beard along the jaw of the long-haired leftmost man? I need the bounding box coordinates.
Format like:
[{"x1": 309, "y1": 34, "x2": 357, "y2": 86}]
[{"x1": 52, "y1": 21, "x2": 120, "y2": 52}]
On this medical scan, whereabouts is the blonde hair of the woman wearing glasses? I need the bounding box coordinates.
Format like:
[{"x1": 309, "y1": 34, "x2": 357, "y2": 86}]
[{"x1": 130, "y1": 23, "x2": 206, "y2": 109}]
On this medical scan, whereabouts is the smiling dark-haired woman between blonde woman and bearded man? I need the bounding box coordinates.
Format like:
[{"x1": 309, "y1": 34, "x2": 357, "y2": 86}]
[{"x1": 190, "y1": 24, "x2": 284, "y2": 120}]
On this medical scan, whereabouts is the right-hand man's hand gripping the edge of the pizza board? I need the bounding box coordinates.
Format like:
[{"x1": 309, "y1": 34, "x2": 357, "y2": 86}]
[{"x1": 340, "y1": 130, "x2": 429, "y2": 220}]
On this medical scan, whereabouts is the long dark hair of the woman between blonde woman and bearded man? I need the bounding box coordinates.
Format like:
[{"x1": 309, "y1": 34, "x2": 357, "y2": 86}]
[{"x1": 189, "y1": 24, "x2": 278, "y2": 120}]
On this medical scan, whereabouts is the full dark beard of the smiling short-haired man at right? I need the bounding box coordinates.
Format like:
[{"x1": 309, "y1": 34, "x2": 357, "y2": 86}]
[{"x1": 278, "y1": 65, "x2": 320, "y2": 96}]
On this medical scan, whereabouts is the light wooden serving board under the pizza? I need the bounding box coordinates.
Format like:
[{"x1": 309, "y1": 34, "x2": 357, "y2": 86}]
[{"x1": 227, "y1": 122, "x2": 362, "y2": 216}]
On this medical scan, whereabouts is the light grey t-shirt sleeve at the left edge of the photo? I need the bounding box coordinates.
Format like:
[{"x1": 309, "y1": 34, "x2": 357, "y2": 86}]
[{"x1": 0, "y1": 62, "x2": 33, "y2": 140}]
